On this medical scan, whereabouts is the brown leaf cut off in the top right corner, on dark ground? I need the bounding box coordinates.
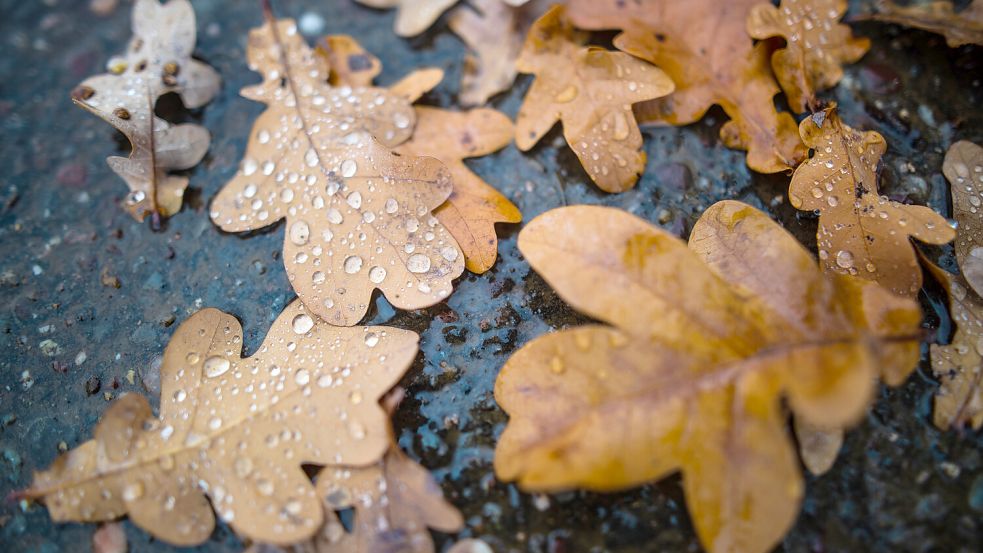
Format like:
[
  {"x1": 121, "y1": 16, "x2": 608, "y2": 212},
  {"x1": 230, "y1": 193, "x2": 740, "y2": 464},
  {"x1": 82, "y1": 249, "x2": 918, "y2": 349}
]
[{"x1": 868, "y1": 0, "x2": 983, "y2": 48}]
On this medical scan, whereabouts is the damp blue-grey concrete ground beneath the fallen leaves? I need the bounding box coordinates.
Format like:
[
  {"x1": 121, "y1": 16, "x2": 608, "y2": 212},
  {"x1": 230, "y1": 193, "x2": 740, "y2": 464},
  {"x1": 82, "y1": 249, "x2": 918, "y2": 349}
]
[{"x1": 0, "y1": 0, "x2": 983, "y2": 553}]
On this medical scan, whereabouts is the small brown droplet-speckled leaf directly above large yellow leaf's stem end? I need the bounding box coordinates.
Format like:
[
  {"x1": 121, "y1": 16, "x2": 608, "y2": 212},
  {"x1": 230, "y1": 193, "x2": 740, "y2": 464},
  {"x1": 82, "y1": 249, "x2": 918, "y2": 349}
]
[{"x1": 788, "y1": 106, "x2": 955, "y2": 297}]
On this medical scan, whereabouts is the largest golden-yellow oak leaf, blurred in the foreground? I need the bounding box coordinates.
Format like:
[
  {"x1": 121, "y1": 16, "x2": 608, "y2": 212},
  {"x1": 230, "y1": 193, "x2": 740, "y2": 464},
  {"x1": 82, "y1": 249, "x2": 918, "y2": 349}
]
[{"x1": 495, "y1": 201, "x2": 921, "y2": 553}]
